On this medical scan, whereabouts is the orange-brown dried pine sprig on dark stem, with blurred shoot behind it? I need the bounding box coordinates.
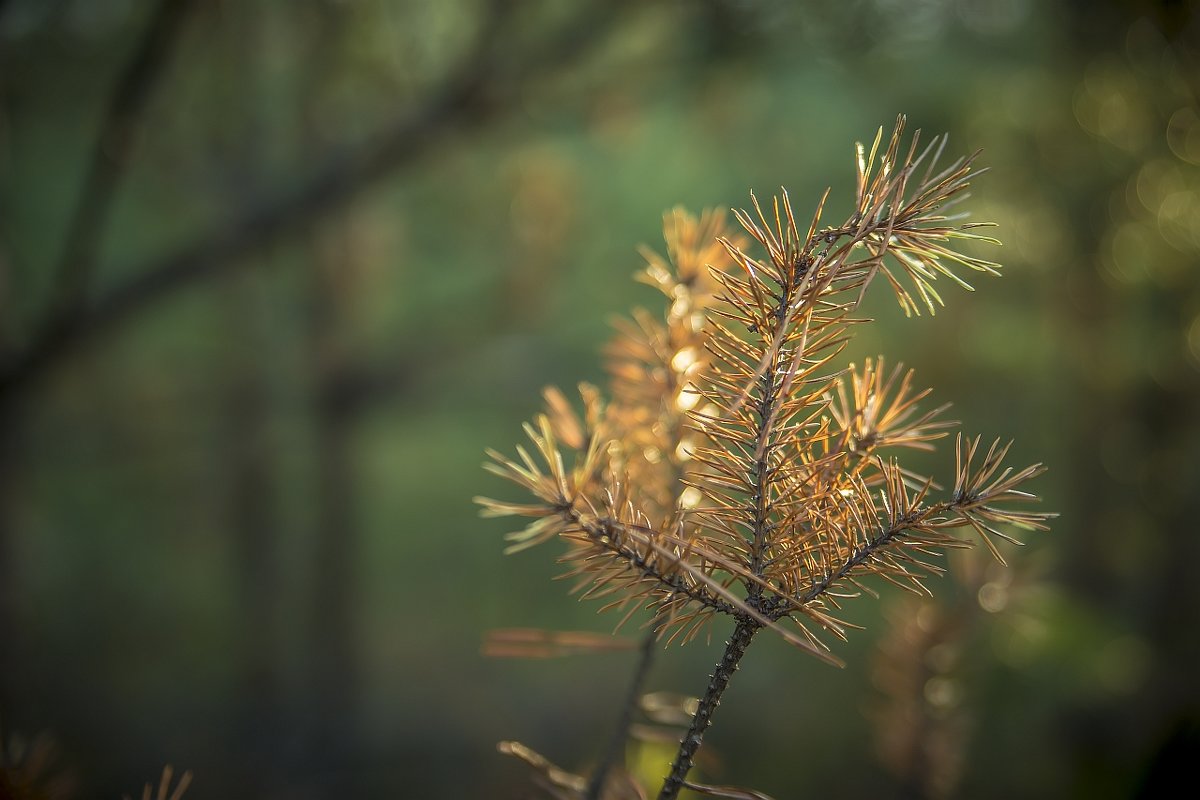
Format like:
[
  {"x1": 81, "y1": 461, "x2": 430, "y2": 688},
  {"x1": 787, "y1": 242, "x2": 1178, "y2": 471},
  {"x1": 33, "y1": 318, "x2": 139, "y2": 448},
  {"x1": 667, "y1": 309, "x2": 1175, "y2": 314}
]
[{"x1": 479, "y1": 118, "x2": 1051, "y2": 799}]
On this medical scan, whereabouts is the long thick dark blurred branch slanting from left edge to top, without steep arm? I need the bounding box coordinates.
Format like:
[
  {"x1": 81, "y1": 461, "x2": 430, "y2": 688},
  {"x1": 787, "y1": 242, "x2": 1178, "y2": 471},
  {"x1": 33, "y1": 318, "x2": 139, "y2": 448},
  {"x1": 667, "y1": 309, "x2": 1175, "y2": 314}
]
[{"x1": 0, "y1": 0, "x2": 624, "y2": 397}]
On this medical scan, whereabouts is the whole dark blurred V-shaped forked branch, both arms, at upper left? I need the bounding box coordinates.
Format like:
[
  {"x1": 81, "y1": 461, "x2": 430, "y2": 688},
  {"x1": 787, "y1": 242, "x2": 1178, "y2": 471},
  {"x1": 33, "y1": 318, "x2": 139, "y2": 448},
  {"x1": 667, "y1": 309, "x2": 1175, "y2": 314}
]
[{"x1": 0, "y1": 0, "x2": 622, "y2": 393}]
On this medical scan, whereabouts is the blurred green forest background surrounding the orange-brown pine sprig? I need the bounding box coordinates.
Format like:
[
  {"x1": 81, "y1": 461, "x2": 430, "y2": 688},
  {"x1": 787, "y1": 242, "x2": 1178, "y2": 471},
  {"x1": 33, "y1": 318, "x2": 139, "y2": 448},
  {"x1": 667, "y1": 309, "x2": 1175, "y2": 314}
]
[{"x1": 0, "y1": 0, "x2": 1200, "y2": 800}]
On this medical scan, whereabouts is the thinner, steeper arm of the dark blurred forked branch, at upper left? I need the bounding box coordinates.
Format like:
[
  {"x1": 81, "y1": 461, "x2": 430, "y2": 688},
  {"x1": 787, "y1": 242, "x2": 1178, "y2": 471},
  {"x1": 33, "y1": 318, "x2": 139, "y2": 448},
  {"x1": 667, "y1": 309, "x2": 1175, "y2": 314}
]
[{"x1": 46, "y1": 0, "x2": 193, "y2": 329}]
